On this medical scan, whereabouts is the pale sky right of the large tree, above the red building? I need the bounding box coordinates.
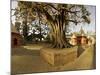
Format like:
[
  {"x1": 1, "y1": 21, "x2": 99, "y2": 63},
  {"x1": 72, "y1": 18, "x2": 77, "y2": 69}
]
[{"x1": 70, "y1": 5, "x2": 96, "y2": 32}]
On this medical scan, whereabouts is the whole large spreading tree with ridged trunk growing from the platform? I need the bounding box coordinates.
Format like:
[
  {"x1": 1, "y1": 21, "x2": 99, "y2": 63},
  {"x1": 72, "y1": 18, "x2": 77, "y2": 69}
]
[{"x1": 16, "y1": 1, "x2": 90, "y2": 48}]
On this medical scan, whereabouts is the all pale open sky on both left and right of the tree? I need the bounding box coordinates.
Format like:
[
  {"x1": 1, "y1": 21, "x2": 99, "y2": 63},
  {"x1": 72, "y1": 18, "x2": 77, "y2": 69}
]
[{"x1": 11, "y1": 1, "x2": 96, "y2": 32}]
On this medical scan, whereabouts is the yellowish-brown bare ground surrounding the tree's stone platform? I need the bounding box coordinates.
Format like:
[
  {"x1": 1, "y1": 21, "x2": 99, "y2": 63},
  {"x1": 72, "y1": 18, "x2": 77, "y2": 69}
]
[{"x1": 11, "y1": 44, "x2": 95, "y2": 75}]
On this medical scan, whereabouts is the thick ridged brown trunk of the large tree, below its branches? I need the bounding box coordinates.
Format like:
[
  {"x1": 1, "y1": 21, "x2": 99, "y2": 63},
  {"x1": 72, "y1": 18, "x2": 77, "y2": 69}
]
[{"x1": 50, "y1": 25, "x2": 68, "y2": 48}]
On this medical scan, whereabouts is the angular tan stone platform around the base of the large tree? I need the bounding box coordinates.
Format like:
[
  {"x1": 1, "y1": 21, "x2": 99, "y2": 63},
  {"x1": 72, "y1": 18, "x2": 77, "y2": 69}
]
[{"x1": 40, "y1": 47, "x2": 77, "y2": 66}]
